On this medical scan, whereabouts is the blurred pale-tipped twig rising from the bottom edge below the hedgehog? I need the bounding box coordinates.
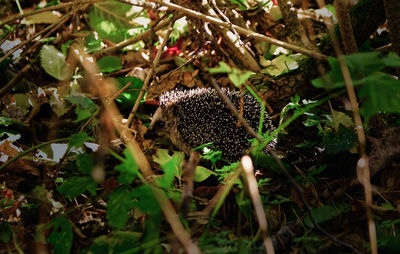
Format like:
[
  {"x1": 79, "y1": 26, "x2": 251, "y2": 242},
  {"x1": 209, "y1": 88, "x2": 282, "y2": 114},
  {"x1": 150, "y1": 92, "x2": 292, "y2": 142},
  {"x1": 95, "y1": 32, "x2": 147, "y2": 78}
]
[{"x1": 240, "y1": 155, "x2": 275, "y2": 254}]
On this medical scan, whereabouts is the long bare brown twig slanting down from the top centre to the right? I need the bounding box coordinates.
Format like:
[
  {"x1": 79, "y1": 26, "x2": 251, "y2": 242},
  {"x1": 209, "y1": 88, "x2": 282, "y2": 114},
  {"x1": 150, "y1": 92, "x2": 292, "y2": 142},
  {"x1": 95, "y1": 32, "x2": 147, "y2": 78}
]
[{"x1": 149, "y1": 0, "x2": 328, "y2": 60}]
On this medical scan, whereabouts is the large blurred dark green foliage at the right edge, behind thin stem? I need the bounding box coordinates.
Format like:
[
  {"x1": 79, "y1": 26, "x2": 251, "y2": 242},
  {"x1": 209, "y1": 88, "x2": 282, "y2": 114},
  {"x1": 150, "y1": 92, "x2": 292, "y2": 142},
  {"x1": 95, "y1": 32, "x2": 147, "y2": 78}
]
[{"x1": 312, "y1": 52, "x2": 400, "y2": 122}]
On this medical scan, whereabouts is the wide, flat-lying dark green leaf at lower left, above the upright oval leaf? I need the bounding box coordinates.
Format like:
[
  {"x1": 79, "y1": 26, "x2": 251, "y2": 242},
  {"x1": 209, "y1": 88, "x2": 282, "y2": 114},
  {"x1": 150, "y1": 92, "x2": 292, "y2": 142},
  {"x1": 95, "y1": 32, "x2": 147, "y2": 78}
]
[{"x1": 57, "y1": 176, "x2": 97, "y2": 198}]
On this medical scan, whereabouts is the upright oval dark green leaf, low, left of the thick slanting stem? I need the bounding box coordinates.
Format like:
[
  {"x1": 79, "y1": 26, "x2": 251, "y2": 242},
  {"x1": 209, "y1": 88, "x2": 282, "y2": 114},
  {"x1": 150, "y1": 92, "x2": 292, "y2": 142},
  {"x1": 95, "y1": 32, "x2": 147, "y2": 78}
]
[{"x1": 107, "y1": 186, "x2": 133, "y2": 229}]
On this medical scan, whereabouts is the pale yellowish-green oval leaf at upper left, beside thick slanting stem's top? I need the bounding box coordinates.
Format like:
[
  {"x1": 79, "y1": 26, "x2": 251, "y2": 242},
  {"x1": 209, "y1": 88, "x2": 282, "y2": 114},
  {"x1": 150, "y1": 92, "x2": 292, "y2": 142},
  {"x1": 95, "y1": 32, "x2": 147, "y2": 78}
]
[{"x1": 40, "y1": 45, "x2": 72, "y2": 80}]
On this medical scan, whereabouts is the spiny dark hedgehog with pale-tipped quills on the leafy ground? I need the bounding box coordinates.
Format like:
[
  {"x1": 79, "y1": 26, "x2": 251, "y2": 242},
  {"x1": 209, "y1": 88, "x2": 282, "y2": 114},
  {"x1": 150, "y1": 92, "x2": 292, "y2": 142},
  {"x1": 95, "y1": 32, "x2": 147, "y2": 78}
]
[{"x1": 144, "y1": 88, "x2": 274, "y2": 162}]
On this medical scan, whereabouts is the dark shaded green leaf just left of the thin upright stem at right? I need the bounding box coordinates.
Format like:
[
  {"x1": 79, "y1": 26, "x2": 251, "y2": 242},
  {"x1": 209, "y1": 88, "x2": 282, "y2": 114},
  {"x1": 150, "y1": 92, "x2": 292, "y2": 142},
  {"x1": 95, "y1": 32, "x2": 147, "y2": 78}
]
[{"x1": 321, "y1": 125, "x2": 357, "y2": 154}]
